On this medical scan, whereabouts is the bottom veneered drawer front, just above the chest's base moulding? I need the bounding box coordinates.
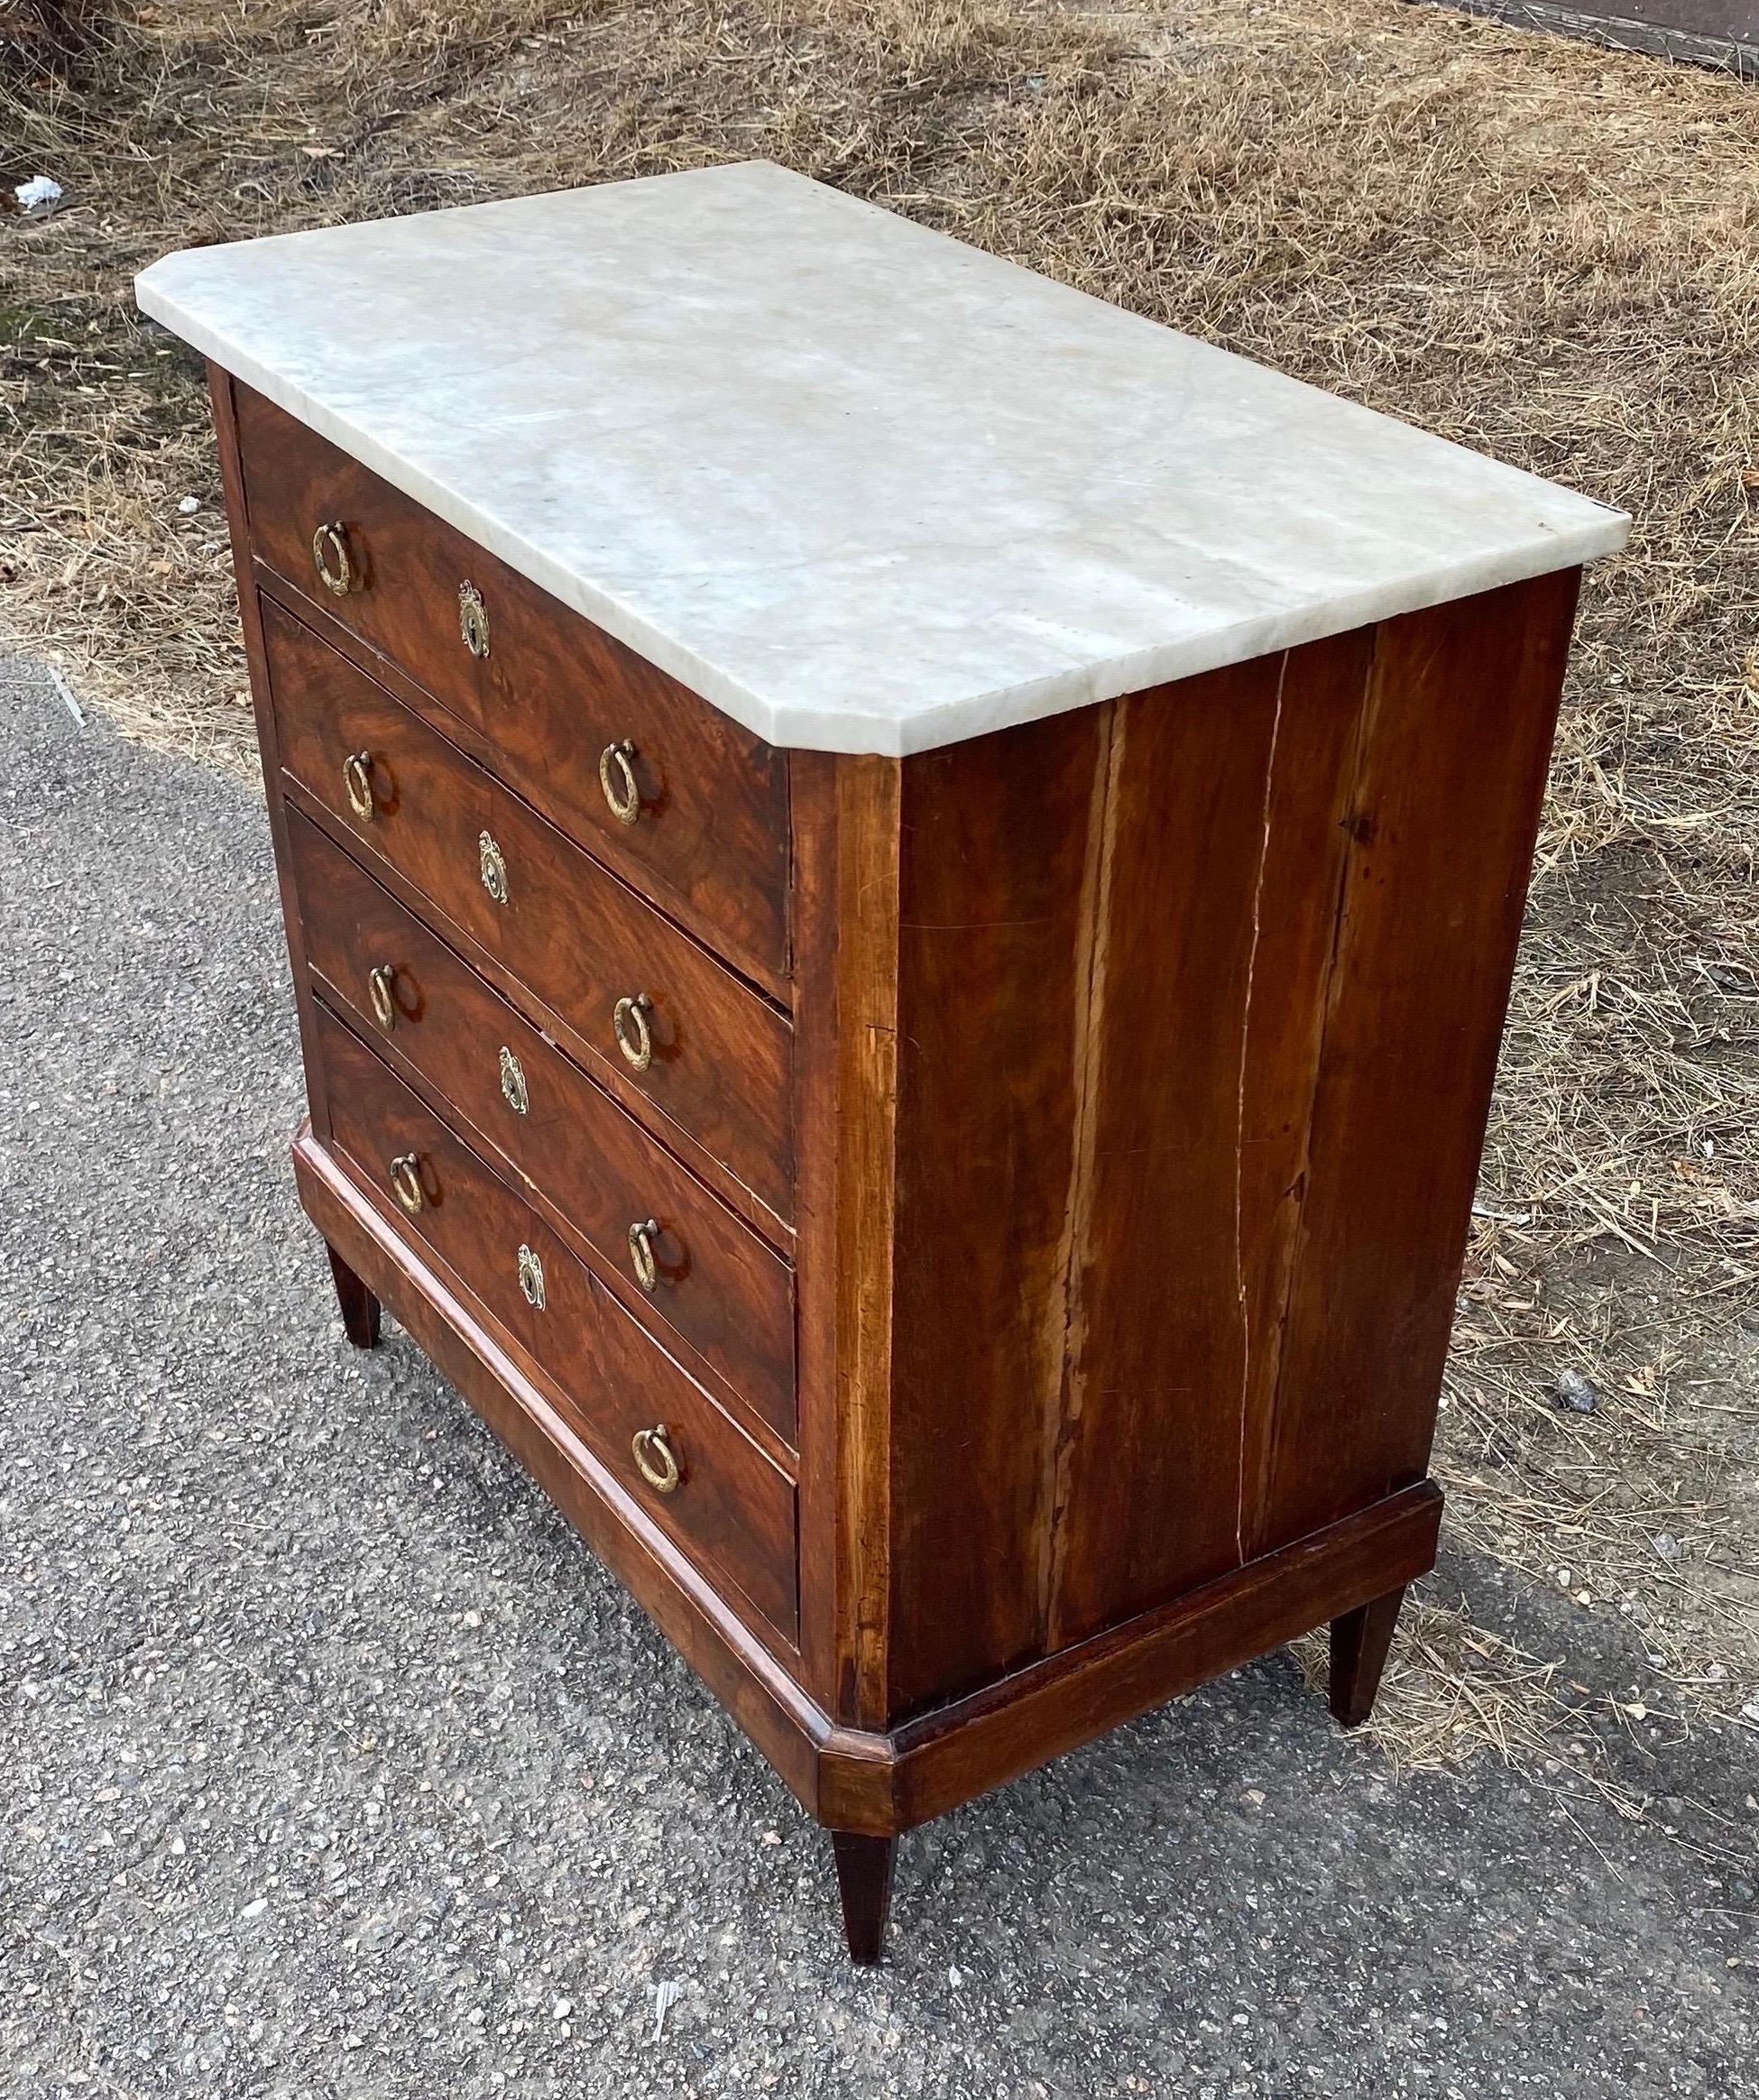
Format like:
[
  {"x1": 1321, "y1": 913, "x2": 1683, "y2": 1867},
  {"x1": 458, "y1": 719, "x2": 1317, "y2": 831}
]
[{"x1": 317, "y1": 1004, "x2": 797, "y2": 1640}]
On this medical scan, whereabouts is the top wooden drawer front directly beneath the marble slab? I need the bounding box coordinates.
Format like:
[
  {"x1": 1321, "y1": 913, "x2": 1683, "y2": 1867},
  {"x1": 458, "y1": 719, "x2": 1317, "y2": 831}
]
[{"x1": 235, "y1": 386, "x2": 787, "y2": 979}]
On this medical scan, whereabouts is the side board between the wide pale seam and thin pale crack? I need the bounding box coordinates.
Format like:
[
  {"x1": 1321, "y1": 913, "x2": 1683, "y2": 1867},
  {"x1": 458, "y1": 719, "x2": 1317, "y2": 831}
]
[{"x1": 1047, "y1": 658, "x2": 1283, "y2": 1648}]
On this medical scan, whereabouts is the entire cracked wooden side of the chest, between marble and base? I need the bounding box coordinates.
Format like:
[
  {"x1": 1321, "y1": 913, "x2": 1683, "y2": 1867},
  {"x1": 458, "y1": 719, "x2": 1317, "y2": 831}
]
[{"x1": 800, "y1": 580, "x2": 1572, "y2": 1727}]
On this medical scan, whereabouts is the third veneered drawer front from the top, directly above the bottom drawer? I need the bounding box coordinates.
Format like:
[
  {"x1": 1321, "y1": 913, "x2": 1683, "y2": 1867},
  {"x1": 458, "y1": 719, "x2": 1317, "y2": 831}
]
[{"x1": 288, "y1": 811, "x2": 794, "y2": 1442}]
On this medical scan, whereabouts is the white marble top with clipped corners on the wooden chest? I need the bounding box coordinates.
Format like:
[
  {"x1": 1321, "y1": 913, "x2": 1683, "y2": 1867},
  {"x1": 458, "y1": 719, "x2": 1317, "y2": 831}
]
[{"x1": 136, "y1": 161, "x2": 1629, "y2": 754}]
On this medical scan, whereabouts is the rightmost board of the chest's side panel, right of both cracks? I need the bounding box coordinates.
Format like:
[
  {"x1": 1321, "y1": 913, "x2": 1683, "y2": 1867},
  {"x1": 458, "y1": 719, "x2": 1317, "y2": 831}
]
[{"x1": 1256, "y1": 571, "x2": 1579, "y2": 1548}]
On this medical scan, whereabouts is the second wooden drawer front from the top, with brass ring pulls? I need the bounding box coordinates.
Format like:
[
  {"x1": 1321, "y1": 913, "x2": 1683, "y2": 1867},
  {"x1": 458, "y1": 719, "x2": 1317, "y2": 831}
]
[{"x1": 262, "y1": 603, "x2": 794, "y2": 1220}]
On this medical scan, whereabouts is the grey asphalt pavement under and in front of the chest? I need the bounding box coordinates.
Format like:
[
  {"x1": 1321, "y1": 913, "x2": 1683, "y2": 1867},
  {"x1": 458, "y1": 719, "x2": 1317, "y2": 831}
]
[{"x1": 0, "y1": 650, "x2": 1759, "y2": 2100}]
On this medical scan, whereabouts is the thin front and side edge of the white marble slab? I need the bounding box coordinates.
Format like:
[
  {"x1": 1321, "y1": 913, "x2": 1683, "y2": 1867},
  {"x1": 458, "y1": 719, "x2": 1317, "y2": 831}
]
[{"x1": 148, "y1": 290, "x2": 1631, "y2": 758}]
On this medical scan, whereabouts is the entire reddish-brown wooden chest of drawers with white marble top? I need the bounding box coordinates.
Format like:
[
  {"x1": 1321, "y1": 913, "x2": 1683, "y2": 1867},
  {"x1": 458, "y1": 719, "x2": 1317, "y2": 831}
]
[{"x1": 141, "y1": 168, "x2": 1625, "y2": 1959}]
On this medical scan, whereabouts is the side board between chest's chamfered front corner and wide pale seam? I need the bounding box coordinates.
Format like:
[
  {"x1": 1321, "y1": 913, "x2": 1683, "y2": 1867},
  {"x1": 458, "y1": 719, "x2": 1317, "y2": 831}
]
[{"x1": 888, "y1": 708, "x2": 1110, "y2": 1716}]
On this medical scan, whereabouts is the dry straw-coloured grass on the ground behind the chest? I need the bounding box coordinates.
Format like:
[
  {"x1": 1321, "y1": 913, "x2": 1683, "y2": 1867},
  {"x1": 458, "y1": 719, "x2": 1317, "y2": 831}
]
[{"x1": 0, "y1": 0, "x2": 1759, "y2": 1762}]
